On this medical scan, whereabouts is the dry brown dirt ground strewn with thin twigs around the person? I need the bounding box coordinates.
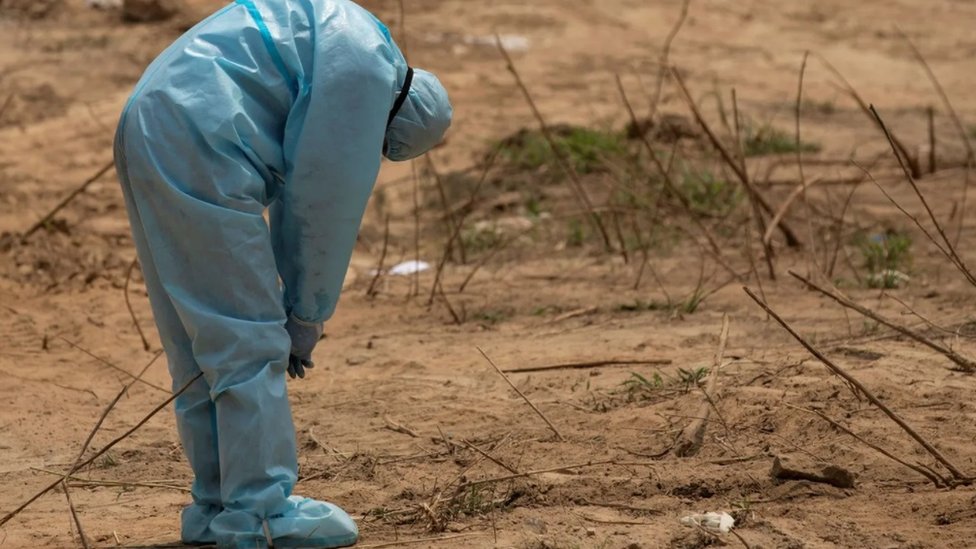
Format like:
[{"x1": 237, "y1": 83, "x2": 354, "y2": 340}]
[{"x1": 0, "y1": 0, "x2": 976, "y2": 549}]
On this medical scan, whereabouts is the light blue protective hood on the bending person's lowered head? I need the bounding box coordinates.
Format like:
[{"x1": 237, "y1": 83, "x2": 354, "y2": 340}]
[{"x1": 383, "y1": 69, "x2": 453, "y2": 161}]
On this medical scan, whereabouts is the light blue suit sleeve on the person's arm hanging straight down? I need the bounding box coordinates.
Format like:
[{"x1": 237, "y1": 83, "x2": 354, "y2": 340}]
[{"x1": 271, "y1": 25, "x2": 403, "y2": 323}]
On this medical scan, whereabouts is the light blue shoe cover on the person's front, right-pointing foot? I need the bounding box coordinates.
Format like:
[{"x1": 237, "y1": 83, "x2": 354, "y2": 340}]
[{"x1": 267, "y1": 496, "x2": 359, "y2": 549}]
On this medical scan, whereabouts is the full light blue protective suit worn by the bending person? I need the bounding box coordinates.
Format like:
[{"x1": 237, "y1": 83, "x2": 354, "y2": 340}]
[{"x1": 109, "y1": 0, "x2": 451, "y2": 548}]
